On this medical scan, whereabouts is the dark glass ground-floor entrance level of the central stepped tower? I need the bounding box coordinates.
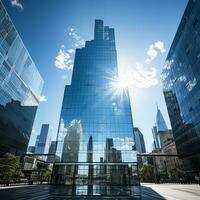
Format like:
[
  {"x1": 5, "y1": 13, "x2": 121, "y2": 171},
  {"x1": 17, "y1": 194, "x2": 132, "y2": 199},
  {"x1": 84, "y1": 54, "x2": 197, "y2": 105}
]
[{"x1": 51, "y1": 163, "x2": 140, "y2": 196}]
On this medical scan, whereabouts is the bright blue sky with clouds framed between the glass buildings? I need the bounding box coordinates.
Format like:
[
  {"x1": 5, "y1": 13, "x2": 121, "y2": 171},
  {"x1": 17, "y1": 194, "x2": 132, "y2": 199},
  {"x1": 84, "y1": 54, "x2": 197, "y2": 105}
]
[{"x1": 2, "y1": 0, "x2": 188, "y2": 151}]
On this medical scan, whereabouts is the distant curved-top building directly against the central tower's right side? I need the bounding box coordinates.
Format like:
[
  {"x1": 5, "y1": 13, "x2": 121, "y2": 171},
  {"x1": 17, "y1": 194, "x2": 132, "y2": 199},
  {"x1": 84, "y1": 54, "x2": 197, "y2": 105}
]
[{"x1": 134, "y1": 127, "x2": 146, "y2": 153}]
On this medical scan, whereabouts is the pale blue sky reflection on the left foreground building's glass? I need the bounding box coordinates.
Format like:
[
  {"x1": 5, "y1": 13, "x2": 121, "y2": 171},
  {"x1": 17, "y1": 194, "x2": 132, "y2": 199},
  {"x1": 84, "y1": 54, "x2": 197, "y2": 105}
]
[{"x1": 0, "y1": 2, "x2": 43, "y2": 106}]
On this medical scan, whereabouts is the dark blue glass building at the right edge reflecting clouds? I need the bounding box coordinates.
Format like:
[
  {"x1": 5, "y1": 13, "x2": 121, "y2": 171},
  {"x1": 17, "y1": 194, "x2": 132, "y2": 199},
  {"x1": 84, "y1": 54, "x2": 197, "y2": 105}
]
[{"x1": 162, "y1": 0, "x2": 200, "y2": 172}]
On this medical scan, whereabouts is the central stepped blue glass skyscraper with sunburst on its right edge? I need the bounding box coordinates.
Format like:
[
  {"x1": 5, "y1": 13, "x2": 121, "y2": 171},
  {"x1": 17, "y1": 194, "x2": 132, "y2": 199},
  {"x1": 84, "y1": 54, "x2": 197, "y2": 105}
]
[{"x1": 52, "y1": 20, "x2": 139, "y2": 195}]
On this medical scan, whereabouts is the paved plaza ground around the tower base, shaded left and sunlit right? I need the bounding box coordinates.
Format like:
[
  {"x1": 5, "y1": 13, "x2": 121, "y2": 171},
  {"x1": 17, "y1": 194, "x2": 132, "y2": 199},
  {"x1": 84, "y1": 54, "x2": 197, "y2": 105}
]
[{"x1": 0, "y1": 184, "x2": 200, "y2": 200}]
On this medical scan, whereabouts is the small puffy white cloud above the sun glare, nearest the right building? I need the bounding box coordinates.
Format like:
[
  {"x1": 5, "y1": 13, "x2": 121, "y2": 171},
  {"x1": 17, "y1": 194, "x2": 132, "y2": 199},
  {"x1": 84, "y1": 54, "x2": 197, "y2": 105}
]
[{"x1": 145, "y1": 41, "x2": 166, "y2": 63}]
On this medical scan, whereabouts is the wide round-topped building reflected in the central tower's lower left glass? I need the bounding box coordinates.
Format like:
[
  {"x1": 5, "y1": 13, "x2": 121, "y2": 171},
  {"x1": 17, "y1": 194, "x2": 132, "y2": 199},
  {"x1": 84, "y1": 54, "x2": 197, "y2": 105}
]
[{"x1": 62, "y1": 120, "x2": 83, "y2": 162}]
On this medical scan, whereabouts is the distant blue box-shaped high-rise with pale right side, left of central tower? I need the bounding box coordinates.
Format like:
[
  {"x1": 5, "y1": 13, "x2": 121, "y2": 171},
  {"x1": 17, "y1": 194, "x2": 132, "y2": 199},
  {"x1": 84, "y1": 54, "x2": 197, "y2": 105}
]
[{"x1": 35, "y1": 124, "x2": 53, "y2": 154}]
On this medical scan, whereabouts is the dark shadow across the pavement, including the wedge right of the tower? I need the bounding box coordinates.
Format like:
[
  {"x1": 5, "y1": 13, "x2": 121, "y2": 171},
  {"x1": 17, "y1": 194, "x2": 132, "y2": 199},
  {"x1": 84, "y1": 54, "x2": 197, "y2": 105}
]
[{"x1": 0, "y1": 185, "x2": 166, "y2": 200}]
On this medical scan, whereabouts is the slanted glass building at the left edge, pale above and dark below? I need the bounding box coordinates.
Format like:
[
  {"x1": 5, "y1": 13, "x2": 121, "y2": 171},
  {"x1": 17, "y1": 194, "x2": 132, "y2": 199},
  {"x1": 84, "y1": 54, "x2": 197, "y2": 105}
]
[{"x1": 0, "y1": 1, "x2": 43, "y2": 155}]
